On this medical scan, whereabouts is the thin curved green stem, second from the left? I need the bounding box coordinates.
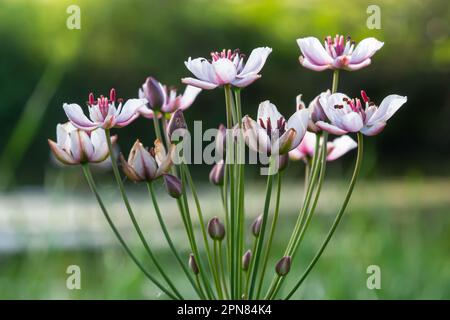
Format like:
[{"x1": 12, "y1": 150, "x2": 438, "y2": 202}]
[{"x1": 105, "y1": 129, "x2": 183, "y2": 299}]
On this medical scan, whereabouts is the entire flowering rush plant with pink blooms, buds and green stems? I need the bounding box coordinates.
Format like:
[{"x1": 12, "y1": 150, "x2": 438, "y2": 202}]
[{"x1": 49, "y1": 35, "x2": 407, "y2": 300}]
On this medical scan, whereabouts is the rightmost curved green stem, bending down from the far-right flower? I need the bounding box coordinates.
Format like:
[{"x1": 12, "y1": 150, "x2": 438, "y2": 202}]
[{"x1": 286, "y1": 132, "x2": 363, "y2": 300}]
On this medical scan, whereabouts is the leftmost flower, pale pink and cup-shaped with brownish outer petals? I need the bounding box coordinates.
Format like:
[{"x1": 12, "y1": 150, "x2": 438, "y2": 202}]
[{"x1": 48, "y1": 122, "x2": 117, "y2": 165}]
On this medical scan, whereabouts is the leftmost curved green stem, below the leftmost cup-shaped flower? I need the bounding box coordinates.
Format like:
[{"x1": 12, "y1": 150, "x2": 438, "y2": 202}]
[{"x1": 82, "y1": 164, "x2": 178, "y2": 300}]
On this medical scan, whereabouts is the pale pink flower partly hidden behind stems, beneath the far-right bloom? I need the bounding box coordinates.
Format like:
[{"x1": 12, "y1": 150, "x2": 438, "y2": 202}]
[{"x1": 289, "y1": 132, "x2": 358, "y2": 162}]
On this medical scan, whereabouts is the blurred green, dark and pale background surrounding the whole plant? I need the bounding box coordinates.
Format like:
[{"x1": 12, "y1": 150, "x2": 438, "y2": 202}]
[{"x1": 0, "y1": 0, "x2": 450, "y2": 299}]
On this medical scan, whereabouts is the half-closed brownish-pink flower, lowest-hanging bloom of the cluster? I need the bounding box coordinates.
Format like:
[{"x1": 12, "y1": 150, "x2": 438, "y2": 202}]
[{"x1": 120, "y1": 139, "x2": 175, "y2": 182}]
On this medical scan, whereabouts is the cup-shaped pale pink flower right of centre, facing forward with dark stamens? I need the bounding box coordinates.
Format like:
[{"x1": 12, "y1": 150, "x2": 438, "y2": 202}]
[{"x1": 242, "y1": 101, "x2": 309, "y2": 154}]
